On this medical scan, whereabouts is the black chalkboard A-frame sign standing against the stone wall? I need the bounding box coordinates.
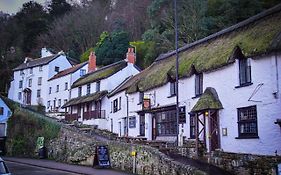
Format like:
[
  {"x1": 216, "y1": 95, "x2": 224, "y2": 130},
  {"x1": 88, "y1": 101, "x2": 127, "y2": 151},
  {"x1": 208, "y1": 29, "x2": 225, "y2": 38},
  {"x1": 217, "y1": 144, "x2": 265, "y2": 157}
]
[{"x1": 94, "y1": 145, "x2": 111, "y2": 168}]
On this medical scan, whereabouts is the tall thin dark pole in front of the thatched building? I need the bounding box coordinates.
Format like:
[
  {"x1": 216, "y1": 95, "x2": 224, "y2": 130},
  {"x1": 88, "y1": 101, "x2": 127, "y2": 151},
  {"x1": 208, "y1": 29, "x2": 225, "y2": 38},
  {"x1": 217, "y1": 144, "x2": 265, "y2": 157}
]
[{"x1": 174, "y1": 0, "x2": 179, "y2": 146}]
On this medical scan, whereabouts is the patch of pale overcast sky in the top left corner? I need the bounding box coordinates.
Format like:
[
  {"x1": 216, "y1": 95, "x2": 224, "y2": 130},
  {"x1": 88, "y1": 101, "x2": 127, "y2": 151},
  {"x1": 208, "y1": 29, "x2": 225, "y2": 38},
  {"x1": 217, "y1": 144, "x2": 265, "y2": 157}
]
[{"x1": 0, "y1": 0, "x2": 45, "y2": 14}]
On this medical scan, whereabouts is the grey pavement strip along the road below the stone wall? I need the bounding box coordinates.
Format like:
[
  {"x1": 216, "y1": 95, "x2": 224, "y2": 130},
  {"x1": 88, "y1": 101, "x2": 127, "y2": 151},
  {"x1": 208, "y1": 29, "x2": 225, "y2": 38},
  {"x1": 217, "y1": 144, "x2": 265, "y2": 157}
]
[{"x1": 2, "y1": 157, "x2": 132, "y2": 175}]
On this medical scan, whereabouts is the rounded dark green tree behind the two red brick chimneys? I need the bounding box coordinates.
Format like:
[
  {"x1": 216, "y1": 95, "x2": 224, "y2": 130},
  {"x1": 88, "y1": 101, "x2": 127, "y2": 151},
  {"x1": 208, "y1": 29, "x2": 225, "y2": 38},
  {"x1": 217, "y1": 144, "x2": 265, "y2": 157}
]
[{"x1": 95, "y1": 31, "x2": 129, "y2": 65}]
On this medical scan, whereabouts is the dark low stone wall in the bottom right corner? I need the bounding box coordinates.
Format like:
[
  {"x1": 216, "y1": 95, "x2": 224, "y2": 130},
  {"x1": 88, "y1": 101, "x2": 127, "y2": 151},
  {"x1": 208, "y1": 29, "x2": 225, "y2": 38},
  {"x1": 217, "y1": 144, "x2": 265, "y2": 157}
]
[{"x1": 209, "y1": 151, "x2": 281, "y2": 175}]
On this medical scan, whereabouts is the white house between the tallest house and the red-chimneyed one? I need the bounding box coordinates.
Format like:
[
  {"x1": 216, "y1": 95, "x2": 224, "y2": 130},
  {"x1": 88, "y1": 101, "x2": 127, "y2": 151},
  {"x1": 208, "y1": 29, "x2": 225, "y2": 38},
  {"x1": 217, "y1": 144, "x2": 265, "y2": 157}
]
[{"x1": 46, "y1": 62, "x2": 88, "y2": 112}]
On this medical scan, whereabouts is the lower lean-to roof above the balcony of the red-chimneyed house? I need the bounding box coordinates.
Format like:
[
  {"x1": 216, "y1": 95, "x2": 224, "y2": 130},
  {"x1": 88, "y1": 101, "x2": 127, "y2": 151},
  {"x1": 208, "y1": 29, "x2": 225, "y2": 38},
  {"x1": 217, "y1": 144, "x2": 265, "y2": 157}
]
[{"x1": 62, "y1": 91, "x2": 107, "y2": 108}]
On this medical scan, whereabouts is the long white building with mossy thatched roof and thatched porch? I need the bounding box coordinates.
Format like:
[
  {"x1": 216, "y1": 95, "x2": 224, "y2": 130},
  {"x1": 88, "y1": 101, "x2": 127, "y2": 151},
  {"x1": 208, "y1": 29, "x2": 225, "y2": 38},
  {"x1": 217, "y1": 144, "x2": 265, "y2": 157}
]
[{"x1": 105, "y1": 5, "x2": 281, "y2": 155}]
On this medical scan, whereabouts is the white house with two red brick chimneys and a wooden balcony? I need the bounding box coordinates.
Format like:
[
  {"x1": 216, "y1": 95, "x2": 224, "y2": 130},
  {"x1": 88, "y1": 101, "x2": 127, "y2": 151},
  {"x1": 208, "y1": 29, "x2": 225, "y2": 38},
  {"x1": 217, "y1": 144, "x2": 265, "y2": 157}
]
[{"x1": 63, "y1": 48, "x2": 139, "y2": 129}]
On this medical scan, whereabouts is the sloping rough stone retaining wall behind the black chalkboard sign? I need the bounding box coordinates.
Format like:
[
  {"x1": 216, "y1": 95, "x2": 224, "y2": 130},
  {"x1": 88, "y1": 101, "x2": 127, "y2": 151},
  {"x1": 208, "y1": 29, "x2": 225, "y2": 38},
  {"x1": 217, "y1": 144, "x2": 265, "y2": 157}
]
[{"x1": 47, "y1": 127, "x2": 204, "y2": 175}]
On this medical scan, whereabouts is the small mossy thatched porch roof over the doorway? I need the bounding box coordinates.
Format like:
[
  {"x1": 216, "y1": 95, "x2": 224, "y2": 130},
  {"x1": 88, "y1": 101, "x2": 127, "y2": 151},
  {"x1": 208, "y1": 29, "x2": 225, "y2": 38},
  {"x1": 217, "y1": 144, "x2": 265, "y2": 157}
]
[{"x1": 191, "y1": 87, "x2": 223, "y2": 112}]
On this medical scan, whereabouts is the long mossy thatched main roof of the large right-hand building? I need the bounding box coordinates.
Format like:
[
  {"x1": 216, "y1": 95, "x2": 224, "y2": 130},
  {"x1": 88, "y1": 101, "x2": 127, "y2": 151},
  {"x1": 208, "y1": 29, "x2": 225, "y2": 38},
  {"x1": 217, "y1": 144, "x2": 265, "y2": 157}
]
[{"x1": 124, "y1": 4, "x2": 281, "y2": 93}]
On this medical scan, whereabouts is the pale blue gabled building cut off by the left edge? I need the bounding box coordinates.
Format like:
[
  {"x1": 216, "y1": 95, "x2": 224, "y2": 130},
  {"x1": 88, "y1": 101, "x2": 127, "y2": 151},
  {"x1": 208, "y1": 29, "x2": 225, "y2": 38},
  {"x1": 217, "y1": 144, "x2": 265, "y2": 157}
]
[{"x1": 0, "y1": 97, "x2": 12, "y2": 137}]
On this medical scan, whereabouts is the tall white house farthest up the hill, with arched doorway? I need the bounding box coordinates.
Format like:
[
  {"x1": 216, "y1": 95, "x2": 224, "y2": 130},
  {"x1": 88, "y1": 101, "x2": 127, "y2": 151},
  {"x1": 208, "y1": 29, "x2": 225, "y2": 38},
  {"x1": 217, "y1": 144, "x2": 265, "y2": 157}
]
[{"x1": 8, "y1": 48, "x2": 72, "y2": 106}]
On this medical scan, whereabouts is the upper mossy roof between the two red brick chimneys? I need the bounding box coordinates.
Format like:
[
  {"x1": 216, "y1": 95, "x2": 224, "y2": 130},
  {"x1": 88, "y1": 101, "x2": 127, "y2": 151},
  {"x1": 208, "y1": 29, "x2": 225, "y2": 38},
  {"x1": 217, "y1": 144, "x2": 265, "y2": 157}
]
[{"x1": 71, "y1": 60, "x2": 127, "y2": 88}]
